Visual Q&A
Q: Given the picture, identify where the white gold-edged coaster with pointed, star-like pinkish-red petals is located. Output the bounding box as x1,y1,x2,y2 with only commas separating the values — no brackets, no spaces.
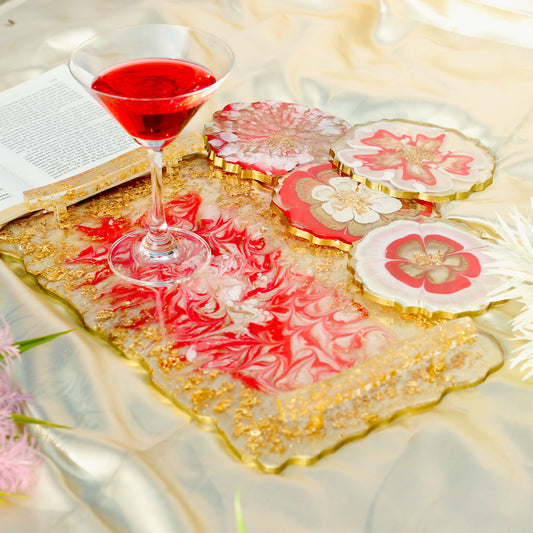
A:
331,120,495,202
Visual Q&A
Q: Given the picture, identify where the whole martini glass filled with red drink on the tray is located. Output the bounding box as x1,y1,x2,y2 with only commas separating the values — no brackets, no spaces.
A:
69,24,233,287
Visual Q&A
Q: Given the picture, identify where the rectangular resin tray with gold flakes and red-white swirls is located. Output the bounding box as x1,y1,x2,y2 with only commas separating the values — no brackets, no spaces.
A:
0,152,503,472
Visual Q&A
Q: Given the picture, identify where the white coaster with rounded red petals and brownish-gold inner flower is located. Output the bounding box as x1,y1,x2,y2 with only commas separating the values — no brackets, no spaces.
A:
349,220,502,318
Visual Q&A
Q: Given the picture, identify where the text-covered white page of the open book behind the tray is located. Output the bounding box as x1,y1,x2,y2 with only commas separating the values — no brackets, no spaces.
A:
0,65,139,188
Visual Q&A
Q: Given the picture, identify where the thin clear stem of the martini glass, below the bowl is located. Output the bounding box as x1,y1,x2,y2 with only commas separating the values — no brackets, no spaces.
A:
142,148,175,255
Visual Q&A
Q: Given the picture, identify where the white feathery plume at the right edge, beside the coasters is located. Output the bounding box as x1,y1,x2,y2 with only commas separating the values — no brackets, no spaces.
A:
488,198,533,380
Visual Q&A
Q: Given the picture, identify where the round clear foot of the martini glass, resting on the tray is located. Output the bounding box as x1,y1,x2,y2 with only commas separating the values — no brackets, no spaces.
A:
108,227,211,287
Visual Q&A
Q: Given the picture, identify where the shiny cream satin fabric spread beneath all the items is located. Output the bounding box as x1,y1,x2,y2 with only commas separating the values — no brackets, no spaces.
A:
0,0,533,533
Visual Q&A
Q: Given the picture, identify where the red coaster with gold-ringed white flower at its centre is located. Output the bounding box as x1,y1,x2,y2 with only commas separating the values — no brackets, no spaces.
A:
272,162,438,251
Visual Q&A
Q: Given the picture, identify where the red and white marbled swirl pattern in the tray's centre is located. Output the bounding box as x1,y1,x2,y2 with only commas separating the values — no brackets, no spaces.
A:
71,195,394,394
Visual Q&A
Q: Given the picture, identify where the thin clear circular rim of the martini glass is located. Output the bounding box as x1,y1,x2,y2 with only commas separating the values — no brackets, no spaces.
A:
68,23,235,102
